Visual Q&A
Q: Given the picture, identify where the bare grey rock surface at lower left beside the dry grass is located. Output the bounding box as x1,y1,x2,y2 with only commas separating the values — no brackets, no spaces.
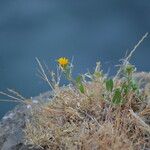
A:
0,92,52,150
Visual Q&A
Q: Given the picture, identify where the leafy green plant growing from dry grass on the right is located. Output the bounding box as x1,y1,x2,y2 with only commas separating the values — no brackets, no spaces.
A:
105,64,140,104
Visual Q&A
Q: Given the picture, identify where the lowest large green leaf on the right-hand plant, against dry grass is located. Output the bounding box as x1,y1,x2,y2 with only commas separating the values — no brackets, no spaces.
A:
112,89,122,104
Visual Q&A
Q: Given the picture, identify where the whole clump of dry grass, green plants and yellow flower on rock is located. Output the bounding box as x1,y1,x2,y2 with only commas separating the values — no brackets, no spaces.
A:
1,35,150,150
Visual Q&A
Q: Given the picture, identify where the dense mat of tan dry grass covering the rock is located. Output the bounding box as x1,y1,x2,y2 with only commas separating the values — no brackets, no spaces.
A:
25,81,150,150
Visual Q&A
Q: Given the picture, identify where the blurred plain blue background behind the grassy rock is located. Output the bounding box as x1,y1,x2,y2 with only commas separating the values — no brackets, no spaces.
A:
0,0,150,118
